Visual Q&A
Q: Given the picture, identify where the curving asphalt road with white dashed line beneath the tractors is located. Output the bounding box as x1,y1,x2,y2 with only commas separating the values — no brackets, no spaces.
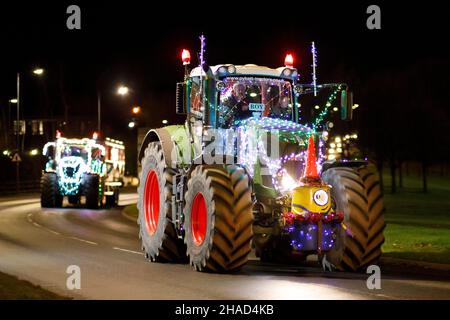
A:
0,190,450,300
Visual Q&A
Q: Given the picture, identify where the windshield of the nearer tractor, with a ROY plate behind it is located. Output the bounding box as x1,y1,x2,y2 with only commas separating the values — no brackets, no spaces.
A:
218,77,293,127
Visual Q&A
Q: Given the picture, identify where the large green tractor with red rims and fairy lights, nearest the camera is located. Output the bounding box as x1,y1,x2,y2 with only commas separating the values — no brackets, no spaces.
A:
138,42,385,272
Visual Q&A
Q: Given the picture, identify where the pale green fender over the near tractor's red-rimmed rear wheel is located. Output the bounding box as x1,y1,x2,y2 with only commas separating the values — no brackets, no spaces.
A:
138,125,190,168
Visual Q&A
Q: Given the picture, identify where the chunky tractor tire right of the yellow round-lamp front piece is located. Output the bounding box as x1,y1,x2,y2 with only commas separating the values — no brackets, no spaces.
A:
322,165,385,271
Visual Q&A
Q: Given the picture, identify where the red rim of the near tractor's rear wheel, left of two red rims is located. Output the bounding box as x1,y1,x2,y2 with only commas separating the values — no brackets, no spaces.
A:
144,170,160,234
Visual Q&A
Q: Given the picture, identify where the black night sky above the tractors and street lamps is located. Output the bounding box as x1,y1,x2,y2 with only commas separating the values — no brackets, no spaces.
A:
0,1,449,172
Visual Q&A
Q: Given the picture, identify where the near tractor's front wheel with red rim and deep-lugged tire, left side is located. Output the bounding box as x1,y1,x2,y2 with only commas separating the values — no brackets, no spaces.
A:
184,165,253,273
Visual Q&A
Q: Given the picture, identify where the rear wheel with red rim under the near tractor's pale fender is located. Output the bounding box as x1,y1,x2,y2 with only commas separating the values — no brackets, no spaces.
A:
137,142,186,262
